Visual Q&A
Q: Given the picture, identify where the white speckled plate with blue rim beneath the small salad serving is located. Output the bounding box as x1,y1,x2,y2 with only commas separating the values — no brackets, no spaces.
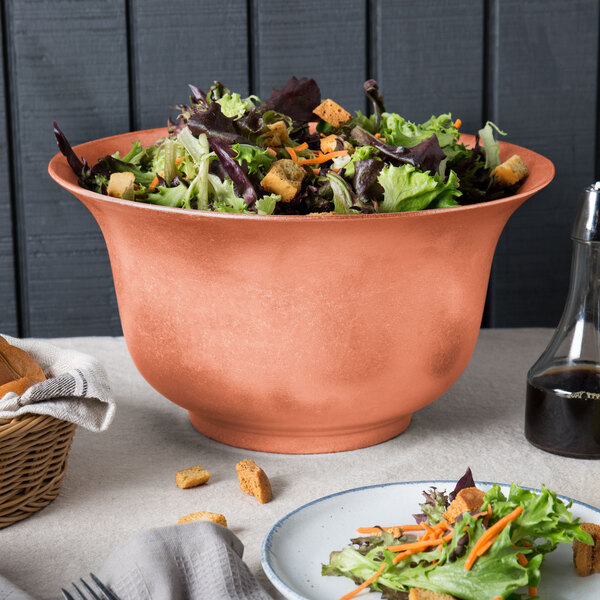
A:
261,481,600,600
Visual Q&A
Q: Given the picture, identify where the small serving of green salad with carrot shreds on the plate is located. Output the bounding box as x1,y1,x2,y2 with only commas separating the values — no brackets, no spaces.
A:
322,469,593,600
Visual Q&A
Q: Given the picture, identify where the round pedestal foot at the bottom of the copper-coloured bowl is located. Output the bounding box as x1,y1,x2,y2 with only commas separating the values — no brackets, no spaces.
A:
189,411,412,454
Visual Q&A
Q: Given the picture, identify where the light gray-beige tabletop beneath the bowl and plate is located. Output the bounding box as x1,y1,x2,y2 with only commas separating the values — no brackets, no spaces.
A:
0,329,600,598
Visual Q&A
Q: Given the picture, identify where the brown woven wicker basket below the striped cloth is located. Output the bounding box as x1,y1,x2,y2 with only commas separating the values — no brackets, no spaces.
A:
0,415,77,529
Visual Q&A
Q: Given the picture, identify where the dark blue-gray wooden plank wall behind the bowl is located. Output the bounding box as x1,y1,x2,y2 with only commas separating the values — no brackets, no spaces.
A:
0,0,599,336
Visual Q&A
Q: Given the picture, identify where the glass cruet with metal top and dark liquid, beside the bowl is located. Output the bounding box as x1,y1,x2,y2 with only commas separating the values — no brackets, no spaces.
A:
525,182,600,458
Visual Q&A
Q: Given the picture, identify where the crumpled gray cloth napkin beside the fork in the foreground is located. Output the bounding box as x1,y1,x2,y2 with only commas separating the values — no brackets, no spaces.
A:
0,522,272,600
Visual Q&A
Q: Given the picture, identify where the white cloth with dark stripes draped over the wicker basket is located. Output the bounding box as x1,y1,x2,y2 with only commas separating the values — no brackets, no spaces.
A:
0,335,115,432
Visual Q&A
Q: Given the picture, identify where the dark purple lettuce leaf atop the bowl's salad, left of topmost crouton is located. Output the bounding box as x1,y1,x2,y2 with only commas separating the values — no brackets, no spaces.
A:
258,77,321,122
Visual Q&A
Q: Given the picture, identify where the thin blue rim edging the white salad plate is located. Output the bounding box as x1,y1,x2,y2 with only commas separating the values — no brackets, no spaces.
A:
260,479,600,600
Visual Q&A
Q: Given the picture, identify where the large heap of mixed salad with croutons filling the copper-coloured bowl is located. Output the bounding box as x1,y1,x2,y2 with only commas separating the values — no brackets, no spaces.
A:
54,77,527,215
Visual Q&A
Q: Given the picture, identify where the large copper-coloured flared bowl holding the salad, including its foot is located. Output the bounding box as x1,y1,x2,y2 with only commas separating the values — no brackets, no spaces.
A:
49,129,554,453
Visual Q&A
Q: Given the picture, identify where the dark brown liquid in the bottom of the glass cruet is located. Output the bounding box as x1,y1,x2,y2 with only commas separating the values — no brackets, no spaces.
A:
525,366,600,458
